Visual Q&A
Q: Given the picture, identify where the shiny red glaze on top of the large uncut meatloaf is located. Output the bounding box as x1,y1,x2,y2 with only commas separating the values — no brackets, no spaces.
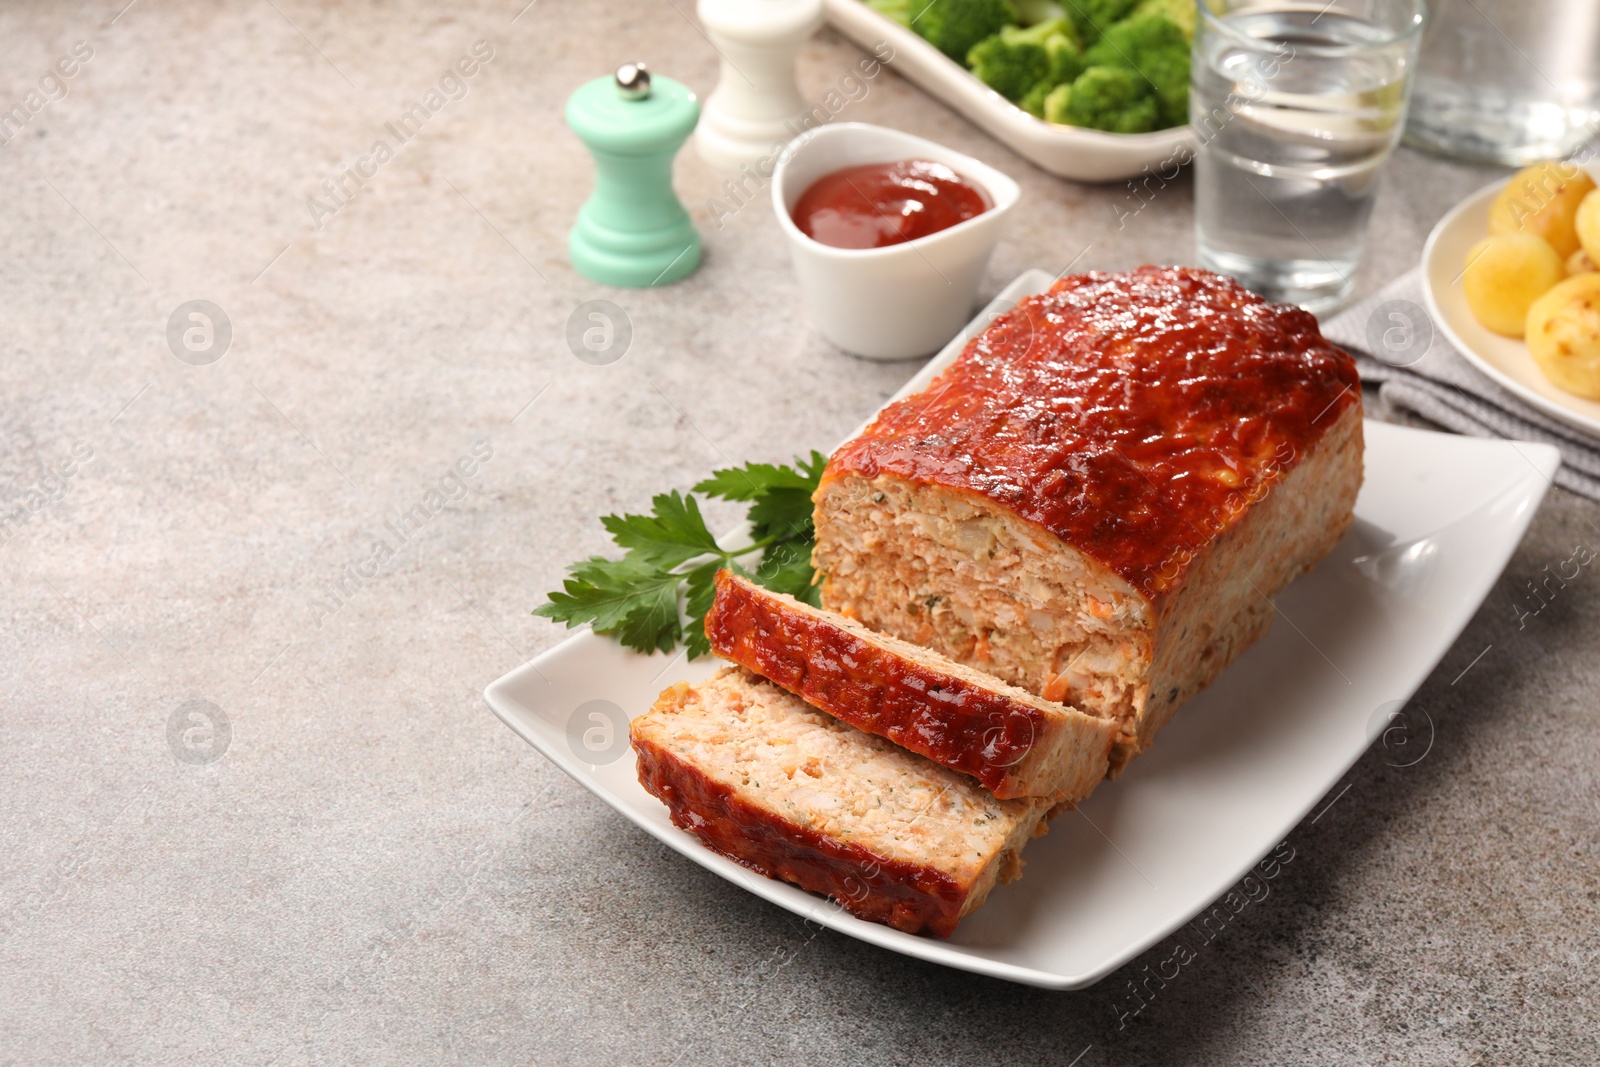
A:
824,267,1360,600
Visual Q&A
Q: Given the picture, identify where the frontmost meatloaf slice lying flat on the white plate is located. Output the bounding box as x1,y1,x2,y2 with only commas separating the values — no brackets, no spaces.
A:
632,667,1050,936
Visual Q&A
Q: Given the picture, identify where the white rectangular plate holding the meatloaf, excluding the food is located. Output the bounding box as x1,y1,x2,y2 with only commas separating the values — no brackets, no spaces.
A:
485,270,1558,989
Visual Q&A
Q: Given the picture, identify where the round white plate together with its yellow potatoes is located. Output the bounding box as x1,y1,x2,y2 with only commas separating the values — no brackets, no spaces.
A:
1422,165,1600,437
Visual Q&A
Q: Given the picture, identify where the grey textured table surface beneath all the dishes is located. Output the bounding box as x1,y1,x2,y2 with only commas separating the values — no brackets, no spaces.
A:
0,0,1600,1067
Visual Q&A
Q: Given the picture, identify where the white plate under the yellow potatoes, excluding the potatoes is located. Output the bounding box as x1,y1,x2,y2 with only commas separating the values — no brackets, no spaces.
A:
1422,179,1600,437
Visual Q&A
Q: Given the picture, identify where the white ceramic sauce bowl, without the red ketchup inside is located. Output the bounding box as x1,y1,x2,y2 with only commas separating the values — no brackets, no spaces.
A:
773,122,1021,360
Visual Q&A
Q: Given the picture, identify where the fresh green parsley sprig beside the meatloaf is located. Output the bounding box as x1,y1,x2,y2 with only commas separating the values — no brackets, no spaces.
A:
533,451,827,659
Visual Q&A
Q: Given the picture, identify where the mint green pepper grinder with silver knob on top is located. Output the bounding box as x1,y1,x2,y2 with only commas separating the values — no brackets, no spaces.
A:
566,62,701,288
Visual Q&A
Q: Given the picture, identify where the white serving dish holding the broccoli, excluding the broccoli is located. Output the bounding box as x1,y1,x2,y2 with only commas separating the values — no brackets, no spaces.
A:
824,0,1195,181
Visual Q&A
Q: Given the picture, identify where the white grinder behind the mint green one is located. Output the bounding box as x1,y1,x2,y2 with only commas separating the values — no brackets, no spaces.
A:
694,0,822,170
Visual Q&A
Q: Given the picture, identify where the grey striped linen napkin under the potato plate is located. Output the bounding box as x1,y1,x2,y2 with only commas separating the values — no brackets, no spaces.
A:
1322,270,1600,501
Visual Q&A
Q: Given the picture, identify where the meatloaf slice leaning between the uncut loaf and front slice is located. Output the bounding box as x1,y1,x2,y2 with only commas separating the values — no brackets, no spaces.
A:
706,571,1117,803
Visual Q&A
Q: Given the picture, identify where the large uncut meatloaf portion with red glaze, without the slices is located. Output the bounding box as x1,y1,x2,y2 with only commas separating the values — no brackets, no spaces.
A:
813,267,1362,771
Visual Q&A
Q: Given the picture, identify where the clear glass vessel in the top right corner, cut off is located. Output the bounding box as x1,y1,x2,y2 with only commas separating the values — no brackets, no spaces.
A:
1405,0,1600,166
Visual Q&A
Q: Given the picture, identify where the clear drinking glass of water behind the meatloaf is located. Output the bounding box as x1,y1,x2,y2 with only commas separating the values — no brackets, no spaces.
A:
1189,0,1426,314
